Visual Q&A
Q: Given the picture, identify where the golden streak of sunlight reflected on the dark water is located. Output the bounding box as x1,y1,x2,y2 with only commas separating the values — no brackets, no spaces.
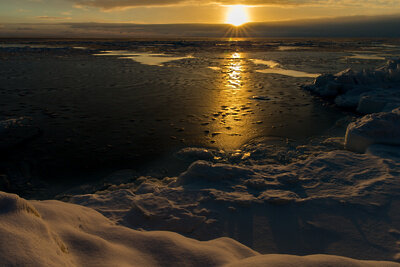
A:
205,52,254,150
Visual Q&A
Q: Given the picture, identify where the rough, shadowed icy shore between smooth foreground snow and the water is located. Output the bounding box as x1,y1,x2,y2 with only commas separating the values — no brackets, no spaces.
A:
67,147,400,260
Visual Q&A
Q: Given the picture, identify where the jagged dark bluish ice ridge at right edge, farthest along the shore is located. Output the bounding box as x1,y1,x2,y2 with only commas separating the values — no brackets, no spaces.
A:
304,59,400,113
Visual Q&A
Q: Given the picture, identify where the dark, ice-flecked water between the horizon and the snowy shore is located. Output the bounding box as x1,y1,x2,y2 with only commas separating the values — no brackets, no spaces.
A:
0,40,398,197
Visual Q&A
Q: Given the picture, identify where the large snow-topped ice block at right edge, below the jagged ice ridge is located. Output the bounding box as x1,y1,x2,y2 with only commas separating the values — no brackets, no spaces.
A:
345,108,400,153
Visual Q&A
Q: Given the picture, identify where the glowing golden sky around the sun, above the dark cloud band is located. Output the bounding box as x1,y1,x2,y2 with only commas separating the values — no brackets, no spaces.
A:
0,0,400,37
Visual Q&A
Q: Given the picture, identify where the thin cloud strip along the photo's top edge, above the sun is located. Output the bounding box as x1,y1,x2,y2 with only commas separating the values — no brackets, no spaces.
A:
69,0,398,10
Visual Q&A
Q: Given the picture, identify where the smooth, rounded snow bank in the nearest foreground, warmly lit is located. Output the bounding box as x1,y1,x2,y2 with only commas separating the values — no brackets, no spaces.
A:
0,192,400,267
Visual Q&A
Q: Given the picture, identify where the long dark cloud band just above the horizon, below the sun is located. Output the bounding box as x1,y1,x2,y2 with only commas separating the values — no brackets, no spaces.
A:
0,15,400,38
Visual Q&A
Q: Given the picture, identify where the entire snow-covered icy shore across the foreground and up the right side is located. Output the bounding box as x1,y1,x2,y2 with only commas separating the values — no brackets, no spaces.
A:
0,52,400,266
